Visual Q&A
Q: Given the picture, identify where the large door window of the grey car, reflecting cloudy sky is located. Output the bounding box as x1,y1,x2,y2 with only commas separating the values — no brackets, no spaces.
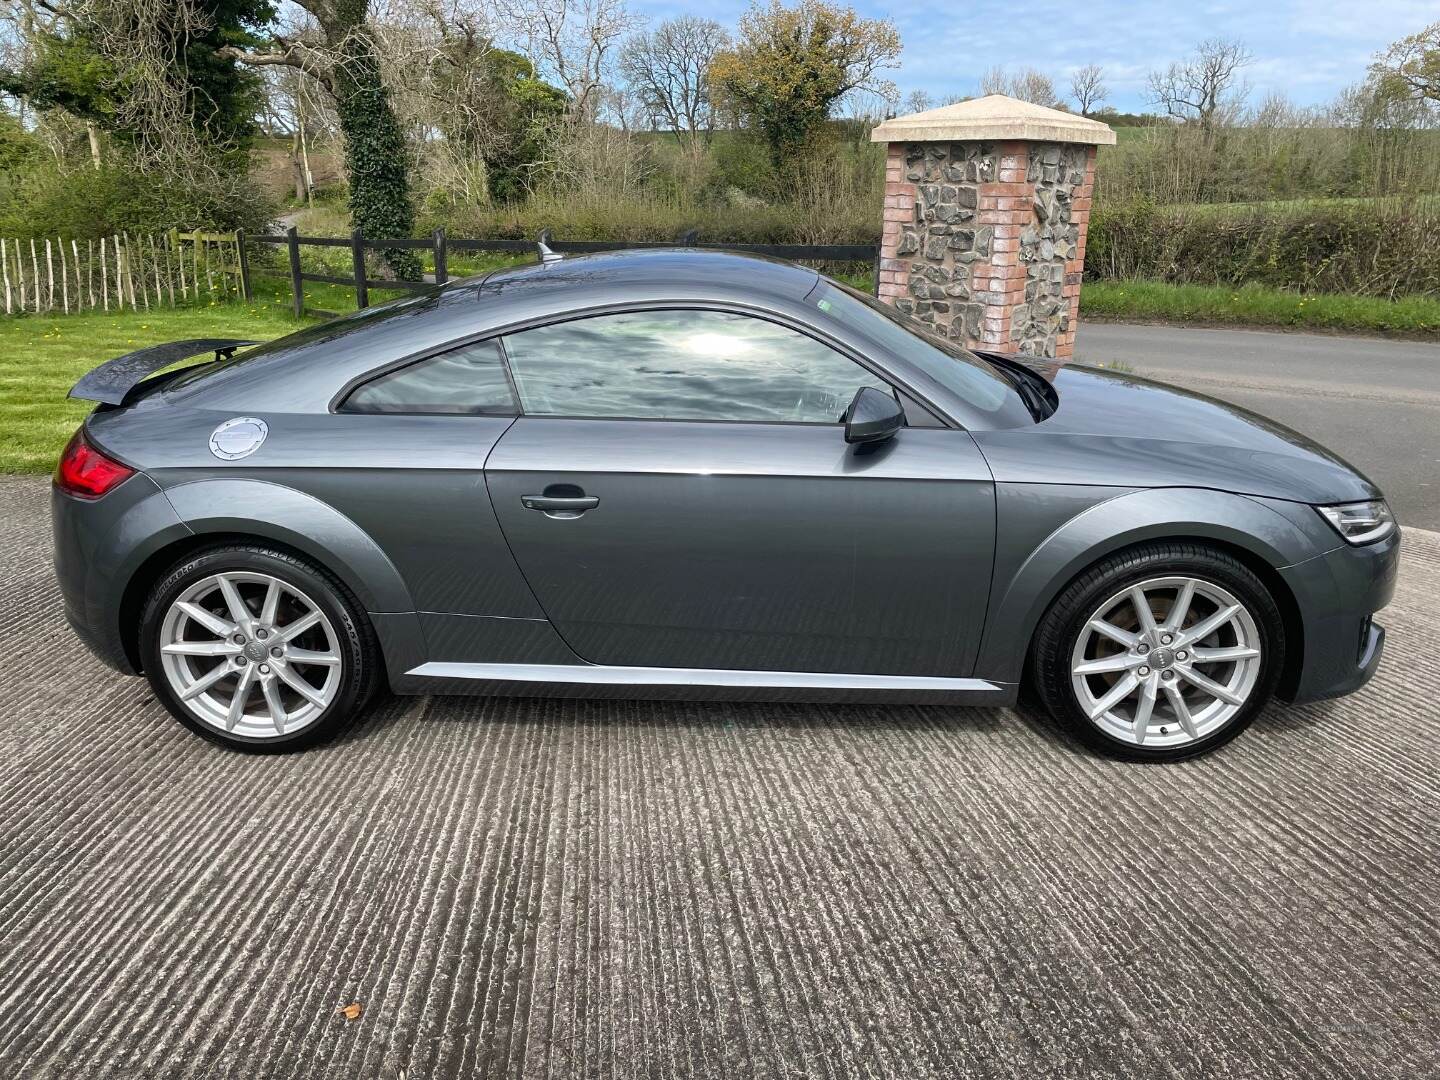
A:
505,310,891,423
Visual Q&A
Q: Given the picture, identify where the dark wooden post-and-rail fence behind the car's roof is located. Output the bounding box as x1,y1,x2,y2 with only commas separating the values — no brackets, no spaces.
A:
240,228,880,317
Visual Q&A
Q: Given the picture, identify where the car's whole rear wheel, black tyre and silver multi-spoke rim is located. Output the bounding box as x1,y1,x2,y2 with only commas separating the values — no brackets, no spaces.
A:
140,544,382,753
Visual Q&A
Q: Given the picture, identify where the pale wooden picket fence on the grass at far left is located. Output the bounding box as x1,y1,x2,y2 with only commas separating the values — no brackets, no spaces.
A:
0,229,251,315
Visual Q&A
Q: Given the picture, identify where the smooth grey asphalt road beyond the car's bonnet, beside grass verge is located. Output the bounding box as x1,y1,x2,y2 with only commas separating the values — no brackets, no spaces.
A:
1076,328,1440,530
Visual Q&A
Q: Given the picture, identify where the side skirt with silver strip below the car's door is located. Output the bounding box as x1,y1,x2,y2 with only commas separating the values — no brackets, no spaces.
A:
393,662,1015,707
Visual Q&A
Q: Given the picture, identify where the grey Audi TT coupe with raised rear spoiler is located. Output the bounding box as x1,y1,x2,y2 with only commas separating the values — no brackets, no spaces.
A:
53,249,1400,760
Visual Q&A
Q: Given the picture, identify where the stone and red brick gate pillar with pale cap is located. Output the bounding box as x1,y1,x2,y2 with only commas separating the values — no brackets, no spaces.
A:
870,94,1115,359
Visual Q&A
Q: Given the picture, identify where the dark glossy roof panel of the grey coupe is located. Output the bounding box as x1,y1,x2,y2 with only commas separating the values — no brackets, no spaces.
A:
481,248,819,300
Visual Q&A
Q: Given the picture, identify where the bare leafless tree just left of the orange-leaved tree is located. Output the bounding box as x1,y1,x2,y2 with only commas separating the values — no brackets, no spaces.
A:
619,14,730,154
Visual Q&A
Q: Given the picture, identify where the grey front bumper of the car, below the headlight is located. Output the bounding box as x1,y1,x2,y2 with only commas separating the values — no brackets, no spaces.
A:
1280,528,1400,701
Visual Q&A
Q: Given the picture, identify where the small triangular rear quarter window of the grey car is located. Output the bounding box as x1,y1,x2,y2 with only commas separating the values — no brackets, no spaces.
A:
340,341,516,416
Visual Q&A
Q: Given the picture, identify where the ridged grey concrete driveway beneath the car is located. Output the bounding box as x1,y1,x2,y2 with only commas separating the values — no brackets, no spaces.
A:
0,480,1440,1080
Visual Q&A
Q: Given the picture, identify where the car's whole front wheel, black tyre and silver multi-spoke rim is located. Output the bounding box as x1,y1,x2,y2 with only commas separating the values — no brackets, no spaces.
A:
1030,541,1286,762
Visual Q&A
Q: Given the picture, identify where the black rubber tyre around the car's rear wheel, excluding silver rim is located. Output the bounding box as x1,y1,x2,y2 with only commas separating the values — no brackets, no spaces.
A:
140,546,373,753
